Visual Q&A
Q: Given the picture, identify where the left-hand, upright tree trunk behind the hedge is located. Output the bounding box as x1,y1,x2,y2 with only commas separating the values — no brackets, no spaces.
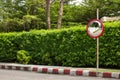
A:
46,0,51,29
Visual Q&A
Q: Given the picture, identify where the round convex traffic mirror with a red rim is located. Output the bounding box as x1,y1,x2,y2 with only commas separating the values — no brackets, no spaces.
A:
87,20,103,38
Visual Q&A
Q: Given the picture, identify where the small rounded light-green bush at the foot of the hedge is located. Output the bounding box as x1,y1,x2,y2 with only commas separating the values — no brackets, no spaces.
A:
17,50,31,64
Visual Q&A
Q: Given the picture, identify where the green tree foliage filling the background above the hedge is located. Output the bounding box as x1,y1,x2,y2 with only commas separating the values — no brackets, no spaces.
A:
0,0,120,32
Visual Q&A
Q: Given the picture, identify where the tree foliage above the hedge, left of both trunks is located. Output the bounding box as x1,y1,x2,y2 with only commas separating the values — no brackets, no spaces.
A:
0,0,45,32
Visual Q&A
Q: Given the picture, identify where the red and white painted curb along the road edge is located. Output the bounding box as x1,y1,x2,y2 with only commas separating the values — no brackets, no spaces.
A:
0,64,120,79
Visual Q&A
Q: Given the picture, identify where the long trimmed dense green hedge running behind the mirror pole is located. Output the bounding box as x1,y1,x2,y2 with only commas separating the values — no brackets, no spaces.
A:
0,22,120,68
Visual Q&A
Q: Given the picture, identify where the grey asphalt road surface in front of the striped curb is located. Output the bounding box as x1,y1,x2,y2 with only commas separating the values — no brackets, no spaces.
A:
0,69,118,80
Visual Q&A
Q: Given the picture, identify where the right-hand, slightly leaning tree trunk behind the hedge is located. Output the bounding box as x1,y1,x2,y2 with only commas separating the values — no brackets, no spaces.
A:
57,0,64,29
